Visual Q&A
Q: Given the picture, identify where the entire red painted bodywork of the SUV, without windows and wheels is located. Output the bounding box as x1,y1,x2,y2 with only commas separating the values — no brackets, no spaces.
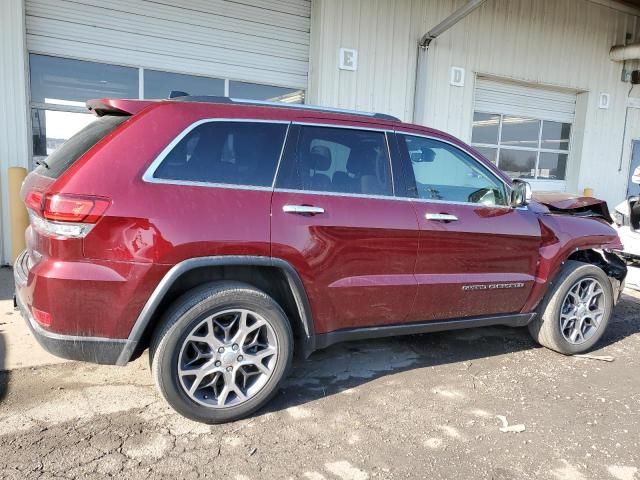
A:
13,100,617,339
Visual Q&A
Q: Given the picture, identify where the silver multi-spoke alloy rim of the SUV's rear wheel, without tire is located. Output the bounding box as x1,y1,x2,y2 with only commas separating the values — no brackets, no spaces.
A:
178,309,278,408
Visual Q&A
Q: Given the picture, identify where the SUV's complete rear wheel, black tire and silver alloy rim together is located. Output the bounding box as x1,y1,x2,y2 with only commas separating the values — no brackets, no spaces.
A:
151,282,293,423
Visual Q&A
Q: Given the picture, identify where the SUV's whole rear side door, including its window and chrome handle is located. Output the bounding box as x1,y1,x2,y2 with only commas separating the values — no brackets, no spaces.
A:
271,124,419,333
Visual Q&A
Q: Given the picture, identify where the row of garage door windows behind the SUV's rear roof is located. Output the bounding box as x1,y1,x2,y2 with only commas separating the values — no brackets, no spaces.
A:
29,54,304,166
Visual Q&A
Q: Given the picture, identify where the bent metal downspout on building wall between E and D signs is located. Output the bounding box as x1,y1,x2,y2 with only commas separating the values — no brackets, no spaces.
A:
413,0,486,123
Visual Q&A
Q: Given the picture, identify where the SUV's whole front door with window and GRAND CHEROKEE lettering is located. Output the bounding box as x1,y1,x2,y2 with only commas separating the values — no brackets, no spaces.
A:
397,130,540,320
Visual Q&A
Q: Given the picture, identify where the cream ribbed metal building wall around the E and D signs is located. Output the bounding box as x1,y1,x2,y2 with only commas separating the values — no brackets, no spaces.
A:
309,0,640,207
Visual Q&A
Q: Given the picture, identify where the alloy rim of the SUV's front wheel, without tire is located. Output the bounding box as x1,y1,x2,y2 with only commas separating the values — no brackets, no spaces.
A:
560,277,605,345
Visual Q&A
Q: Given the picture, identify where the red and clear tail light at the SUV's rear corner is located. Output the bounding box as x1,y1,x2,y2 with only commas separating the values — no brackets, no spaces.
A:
25,191,111,238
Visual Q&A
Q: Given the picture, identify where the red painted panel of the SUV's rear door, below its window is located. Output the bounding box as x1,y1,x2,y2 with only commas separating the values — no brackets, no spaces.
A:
271,192,419,333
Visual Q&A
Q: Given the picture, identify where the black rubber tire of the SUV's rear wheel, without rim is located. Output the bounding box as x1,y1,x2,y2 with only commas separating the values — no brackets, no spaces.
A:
149,282,293,424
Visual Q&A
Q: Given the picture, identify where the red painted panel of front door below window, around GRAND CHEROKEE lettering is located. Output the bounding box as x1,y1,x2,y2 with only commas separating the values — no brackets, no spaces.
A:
412,201,540,321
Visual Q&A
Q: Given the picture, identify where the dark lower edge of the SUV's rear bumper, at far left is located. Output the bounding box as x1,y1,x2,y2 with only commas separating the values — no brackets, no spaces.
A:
13,251,126,365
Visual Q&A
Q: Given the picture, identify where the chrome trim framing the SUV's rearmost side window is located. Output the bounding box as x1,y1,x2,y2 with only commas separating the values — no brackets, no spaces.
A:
142,118,291,191
